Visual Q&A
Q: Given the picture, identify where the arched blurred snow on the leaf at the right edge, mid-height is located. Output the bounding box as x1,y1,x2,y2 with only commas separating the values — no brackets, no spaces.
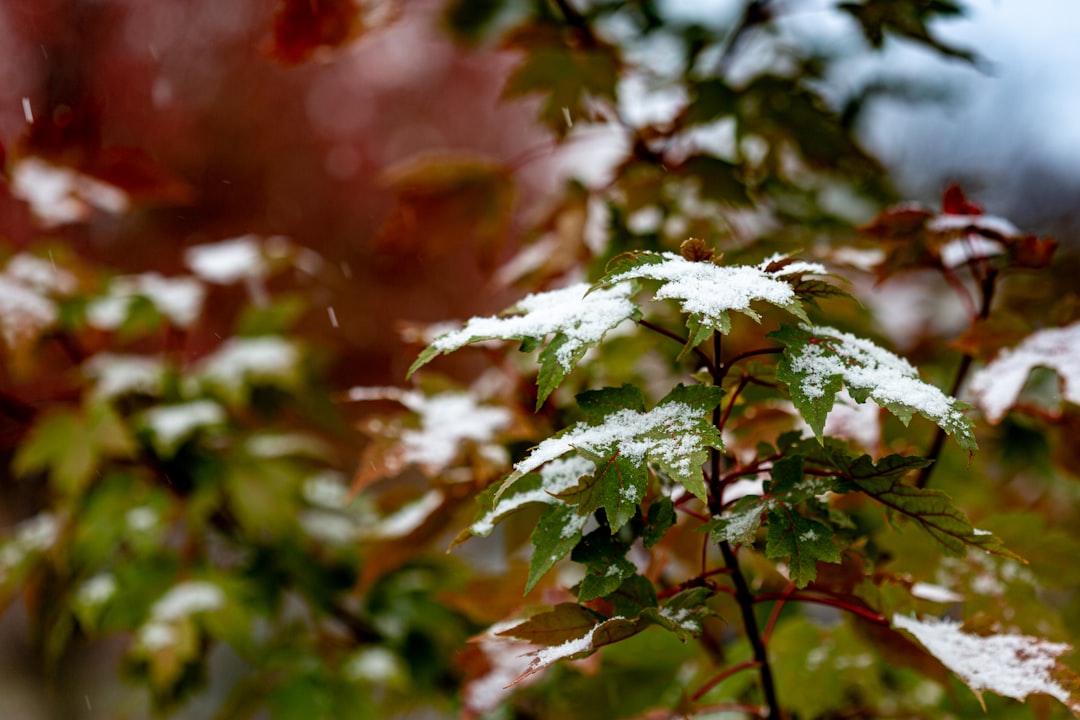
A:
969,323,1080,423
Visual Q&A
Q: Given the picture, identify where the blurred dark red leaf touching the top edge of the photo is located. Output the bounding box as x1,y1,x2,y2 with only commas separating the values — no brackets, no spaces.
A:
267,0,360,65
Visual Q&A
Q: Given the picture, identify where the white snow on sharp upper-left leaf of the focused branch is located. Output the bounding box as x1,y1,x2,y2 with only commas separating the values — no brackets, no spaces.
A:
431,283,635,371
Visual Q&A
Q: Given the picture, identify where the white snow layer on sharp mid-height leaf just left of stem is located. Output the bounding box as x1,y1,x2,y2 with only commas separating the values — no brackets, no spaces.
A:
504,403,701,487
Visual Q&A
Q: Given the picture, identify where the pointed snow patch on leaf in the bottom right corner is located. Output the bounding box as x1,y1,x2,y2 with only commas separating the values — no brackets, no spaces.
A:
892,615,1080,712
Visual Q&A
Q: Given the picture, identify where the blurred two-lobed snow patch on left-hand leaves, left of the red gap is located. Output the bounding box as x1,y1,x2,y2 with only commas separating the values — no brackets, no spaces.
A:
86,272,206,330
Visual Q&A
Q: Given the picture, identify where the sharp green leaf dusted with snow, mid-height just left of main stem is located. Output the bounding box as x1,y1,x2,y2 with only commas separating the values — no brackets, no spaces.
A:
496,385,724,509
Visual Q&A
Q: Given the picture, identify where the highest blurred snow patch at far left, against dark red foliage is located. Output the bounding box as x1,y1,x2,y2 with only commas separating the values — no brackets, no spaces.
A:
11,158,131,228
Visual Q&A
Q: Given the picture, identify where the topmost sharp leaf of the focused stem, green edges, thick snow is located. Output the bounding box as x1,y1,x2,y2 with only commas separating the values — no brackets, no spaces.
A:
595,252,826,354
